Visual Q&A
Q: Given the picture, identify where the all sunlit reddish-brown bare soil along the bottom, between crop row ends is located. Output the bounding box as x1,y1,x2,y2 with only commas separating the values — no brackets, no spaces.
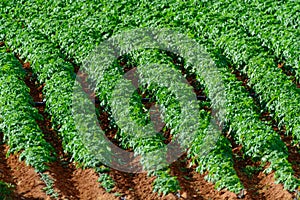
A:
0,145,293,200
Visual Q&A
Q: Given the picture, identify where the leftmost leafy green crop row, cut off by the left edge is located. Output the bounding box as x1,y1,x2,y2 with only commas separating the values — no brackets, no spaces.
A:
0,47,57,197
